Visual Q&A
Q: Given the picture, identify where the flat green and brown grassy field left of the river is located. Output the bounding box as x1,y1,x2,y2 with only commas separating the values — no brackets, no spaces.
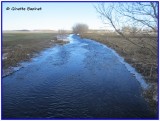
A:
2,32,64,69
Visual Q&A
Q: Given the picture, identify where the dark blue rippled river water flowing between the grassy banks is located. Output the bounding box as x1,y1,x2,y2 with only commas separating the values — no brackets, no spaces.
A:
2,35,156,119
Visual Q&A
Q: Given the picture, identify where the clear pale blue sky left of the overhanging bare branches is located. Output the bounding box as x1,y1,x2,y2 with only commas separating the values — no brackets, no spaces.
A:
2,2,104,30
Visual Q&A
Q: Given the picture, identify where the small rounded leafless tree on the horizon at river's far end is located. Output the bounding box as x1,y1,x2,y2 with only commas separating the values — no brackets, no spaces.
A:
72,23,88,34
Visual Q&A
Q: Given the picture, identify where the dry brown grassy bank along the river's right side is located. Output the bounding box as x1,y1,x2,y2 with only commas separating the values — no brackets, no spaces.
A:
81,33,158,112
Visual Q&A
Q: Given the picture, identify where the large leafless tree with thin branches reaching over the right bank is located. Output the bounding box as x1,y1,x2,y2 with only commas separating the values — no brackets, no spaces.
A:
95,2,158,55
